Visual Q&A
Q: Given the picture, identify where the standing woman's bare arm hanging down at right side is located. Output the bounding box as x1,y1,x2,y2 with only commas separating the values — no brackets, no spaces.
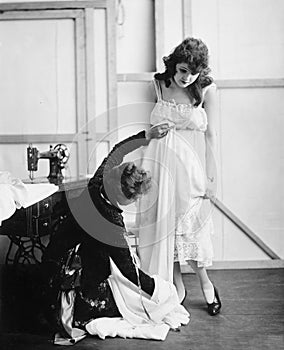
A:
204,84,218,197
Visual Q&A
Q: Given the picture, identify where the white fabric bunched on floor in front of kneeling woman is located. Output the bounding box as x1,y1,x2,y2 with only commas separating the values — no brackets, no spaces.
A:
86,259,190,340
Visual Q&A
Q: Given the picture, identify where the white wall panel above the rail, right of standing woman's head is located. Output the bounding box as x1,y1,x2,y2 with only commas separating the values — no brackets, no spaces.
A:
191,0,284,79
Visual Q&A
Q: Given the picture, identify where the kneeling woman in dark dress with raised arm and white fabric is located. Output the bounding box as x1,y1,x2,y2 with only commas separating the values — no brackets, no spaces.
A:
42,124,189,344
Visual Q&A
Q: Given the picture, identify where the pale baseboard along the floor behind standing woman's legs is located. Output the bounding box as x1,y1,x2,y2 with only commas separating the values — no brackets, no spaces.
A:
181,259,284,273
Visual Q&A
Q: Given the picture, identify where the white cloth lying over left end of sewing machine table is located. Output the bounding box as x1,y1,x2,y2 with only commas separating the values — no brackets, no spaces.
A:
0,171,58,225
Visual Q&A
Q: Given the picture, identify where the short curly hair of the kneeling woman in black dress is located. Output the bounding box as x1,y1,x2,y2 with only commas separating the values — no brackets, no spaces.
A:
120,163,151,200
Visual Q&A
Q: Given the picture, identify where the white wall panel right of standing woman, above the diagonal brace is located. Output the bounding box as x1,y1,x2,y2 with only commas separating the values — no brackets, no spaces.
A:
221,88,284,257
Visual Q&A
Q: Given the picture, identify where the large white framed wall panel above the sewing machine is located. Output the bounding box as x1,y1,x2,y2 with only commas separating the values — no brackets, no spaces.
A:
0,19,76,134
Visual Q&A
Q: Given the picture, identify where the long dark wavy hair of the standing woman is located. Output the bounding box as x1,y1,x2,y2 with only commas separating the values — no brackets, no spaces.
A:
154,38,213,106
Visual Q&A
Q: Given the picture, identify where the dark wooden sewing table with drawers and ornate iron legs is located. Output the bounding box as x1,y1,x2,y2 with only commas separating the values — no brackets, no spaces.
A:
0,178,88,264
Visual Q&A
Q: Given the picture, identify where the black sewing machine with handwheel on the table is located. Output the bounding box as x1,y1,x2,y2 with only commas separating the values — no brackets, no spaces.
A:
27,144,70,181
